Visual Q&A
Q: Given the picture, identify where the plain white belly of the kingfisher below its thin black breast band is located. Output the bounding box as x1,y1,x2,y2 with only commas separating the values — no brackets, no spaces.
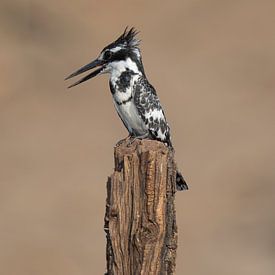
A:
114,100,148,136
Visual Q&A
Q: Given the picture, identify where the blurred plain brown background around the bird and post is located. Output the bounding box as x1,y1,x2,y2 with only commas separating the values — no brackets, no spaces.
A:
0,0,275,275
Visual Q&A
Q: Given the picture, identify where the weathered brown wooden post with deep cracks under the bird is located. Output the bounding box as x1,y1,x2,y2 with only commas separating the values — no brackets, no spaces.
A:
105,140,177,275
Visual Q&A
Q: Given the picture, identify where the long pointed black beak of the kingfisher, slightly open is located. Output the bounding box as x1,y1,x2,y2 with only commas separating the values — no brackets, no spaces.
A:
65,59,104,88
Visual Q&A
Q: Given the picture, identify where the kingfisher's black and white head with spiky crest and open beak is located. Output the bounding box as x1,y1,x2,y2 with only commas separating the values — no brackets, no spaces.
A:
65,28,144,88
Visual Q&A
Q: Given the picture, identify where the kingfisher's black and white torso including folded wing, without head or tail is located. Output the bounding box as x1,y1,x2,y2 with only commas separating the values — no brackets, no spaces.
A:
110,70,171,145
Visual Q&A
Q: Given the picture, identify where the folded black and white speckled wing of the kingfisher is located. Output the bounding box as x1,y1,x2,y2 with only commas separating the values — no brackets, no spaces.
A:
134,77,171,146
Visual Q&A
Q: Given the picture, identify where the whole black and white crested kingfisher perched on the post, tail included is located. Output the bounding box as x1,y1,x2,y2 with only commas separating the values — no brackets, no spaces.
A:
65,27,188,191
